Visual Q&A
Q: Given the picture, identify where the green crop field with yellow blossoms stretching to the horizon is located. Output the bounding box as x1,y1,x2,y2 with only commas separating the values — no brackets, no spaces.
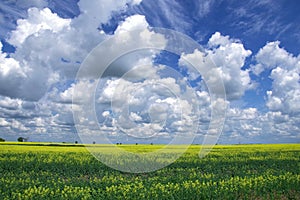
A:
0,142,300,200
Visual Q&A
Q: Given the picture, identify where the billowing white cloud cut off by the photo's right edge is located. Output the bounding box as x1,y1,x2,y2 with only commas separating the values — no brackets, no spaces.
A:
252,41,300,115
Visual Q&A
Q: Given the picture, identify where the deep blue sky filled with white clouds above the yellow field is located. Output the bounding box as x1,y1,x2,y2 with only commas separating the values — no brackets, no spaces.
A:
0,0,300,144
